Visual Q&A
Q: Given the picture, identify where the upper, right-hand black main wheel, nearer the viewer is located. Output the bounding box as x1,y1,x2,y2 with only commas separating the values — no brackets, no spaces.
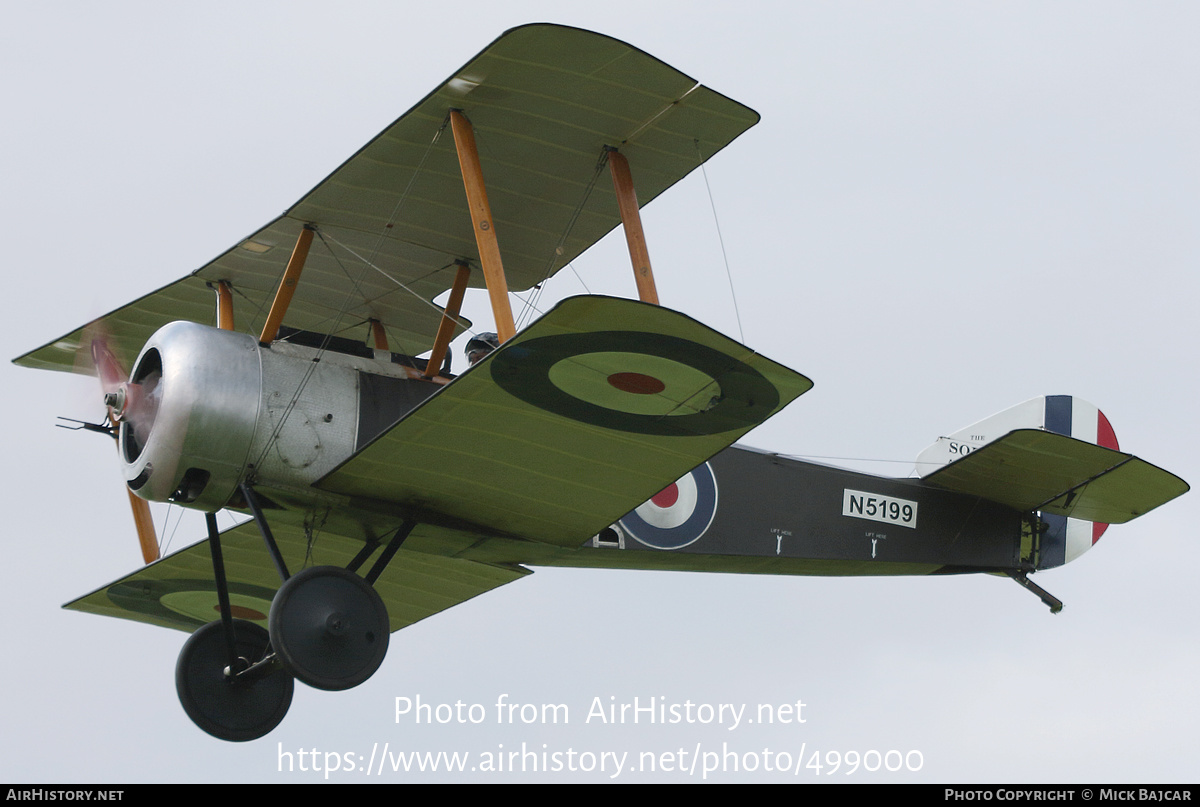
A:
268,566,391,689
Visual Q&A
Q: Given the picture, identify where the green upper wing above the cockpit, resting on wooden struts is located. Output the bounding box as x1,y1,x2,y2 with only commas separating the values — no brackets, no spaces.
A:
17,24,758,372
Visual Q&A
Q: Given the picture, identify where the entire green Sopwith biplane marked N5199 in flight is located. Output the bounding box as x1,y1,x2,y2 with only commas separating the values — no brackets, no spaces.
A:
16,24,1188,741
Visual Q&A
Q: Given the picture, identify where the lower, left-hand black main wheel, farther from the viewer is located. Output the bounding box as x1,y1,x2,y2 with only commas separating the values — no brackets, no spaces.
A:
175,620,295,742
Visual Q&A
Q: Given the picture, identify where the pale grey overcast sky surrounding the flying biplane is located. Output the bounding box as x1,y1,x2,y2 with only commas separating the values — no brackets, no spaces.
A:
0,1,1200,783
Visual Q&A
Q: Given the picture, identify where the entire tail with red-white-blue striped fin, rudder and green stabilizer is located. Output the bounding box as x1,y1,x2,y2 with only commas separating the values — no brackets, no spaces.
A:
917,395,1188,568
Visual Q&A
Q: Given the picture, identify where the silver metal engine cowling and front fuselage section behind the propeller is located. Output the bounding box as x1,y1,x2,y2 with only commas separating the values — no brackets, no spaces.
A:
114,322,438,510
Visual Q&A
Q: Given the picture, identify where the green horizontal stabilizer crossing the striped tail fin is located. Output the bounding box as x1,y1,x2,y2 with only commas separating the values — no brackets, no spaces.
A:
923,429,1188,524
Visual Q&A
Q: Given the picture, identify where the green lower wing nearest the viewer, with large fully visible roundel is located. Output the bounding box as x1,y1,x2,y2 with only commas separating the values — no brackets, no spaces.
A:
317,297,812,546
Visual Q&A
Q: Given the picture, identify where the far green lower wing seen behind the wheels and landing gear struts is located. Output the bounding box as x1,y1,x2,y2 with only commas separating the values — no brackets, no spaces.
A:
64,521,530,633
